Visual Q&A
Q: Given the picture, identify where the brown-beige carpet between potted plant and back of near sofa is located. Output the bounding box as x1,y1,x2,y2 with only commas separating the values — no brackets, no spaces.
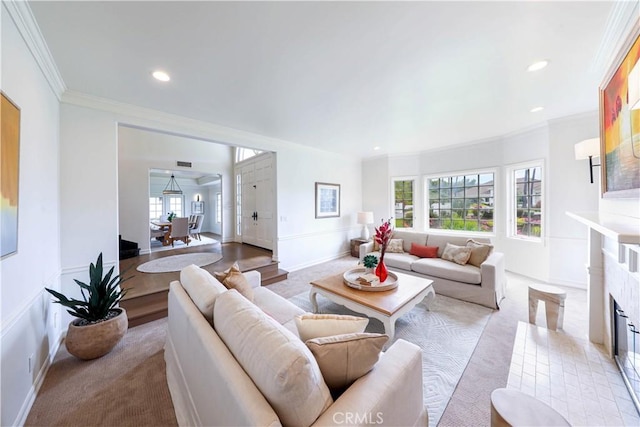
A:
25,319,177,427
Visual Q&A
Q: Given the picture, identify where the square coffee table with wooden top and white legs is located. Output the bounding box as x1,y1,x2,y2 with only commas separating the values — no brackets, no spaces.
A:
309,271,436,343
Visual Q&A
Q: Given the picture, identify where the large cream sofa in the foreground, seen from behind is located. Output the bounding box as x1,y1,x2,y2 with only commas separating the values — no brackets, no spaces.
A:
165,266,428,426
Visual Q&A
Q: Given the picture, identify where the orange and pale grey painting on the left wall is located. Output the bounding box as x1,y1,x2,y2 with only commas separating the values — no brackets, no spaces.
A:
0,93,20,258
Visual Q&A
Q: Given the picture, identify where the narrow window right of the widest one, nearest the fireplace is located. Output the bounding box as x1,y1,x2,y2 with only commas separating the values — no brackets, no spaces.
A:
510,163,543,239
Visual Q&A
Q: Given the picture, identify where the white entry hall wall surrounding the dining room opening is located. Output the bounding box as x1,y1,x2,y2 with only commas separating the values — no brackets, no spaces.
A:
118,126,234,253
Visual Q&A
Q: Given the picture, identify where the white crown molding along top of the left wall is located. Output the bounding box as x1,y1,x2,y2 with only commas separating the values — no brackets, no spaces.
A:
2,0,67,100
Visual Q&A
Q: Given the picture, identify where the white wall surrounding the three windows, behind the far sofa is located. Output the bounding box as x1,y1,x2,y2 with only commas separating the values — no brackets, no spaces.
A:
362,112,598,287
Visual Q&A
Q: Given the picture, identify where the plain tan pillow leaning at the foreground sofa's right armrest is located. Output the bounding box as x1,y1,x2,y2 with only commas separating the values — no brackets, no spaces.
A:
306,333,389,391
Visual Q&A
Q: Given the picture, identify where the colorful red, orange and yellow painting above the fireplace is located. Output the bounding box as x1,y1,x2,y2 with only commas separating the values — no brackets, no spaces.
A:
600,24,640,198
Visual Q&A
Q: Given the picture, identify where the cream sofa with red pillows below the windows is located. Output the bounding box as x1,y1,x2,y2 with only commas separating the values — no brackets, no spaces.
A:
360,230,506,309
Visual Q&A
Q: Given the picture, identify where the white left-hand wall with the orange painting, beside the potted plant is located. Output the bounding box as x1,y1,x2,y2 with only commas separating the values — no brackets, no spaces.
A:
0,2,60,426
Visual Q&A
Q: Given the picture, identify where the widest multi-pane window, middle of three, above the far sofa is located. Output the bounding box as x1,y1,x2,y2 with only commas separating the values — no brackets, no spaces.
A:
426,172,495,233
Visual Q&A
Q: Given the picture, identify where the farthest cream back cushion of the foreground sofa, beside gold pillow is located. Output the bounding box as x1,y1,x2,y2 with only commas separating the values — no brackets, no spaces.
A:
180,264,227,323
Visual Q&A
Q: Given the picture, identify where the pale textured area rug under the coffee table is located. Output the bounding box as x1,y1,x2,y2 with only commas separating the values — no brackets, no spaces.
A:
289,292,493,426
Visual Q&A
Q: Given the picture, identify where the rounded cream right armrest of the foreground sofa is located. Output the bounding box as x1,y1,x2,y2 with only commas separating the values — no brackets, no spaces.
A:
314,339,428,426
